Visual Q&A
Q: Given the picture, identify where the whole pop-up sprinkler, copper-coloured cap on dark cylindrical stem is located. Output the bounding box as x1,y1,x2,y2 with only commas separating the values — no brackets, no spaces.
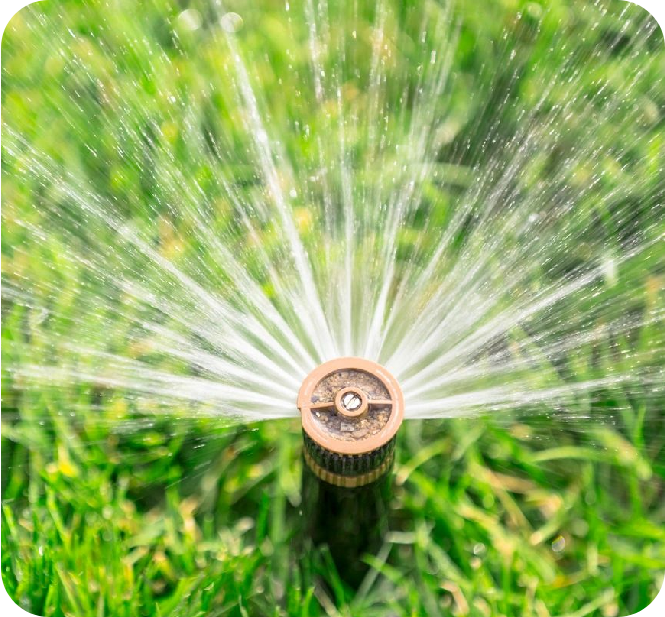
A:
298,358,404,586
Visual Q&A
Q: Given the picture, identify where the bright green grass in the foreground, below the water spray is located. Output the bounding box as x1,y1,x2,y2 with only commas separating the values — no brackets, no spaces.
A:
0,398,665,617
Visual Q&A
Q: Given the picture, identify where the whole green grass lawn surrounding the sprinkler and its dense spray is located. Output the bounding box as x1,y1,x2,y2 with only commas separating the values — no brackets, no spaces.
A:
0,0,665,617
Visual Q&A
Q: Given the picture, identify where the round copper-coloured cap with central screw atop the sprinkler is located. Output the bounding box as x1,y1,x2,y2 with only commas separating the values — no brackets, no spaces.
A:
298,358,404,454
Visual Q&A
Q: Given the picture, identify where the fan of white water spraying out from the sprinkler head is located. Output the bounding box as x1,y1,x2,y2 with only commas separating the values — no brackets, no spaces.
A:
0,0,665,434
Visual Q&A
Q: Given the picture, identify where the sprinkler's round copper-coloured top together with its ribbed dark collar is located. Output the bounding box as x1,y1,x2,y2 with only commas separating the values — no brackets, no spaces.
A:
298,357,404,486
